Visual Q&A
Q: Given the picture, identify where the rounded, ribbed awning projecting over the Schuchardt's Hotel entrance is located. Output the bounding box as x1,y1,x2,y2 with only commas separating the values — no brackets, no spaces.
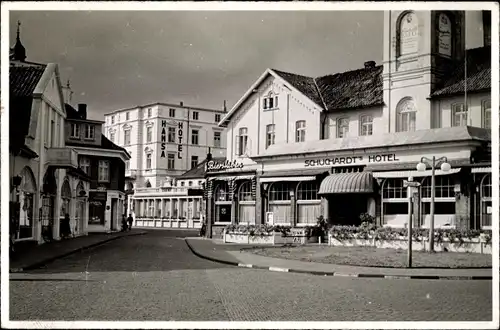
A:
318,172,373,195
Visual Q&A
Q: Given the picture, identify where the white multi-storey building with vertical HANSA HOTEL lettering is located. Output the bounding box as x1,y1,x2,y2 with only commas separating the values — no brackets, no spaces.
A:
103,102,226,190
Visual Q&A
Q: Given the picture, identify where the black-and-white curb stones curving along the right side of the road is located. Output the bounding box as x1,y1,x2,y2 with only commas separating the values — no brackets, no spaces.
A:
184,239,493,281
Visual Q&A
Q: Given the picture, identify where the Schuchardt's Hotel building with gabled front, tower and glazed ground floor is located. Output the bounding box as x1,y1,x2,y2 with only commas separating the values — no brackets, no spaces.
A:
206,11,492,235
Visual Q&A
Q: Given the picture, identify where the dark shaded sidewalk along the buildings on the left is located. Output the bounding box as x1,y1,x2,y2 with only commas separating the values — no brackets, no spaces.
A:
10,230,146,273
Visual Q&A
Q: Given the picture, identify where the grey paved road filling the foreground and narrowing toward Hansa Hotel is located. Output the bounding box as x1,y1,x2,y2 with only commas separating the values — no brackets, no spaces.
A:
10,230,492,321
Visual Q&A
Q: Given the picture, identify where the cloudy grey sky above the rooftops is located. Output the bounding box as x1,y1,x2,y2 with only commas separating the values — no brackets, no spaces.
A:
10,11,484,120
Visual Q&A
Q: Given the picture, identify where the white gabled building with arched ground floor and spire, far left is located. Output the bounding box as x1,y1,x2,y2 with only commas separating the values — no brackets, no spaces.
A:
9,22,89,250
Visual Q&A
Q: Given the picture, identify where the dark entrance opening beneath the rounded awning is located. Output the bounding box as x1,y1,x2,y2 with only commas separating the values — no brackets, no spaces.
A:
329,194,368,226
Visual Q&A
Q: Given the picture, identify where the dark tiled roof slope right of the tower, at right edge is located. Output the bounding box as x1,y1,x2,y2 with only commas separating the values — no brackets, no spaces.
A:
431,46,491,97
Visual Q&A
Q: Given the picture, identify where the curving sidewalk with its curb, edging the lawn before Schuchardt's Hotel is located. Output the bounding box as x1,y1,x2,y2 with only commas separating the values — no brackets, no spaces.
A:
186,238,492,280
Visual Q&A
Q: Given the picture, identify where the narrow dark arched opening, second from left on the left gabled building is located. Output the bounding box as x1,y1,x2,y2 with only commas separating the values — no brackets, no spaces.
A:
40,168,57,241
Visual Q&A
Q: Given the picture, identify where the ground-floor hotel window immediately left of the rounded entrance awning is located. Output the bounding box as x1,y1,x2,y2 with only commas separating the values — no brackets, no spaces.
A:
297,181,321,225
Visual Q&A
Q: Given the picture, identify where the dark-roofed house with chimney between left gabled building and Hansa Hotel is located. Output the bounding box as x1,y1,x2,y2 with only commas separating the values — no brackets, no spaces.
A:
64,104,130,232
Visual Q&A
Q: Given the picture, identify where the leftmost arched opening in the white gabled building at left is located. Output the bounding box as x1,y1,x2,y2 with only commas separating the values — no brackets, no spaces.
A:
16,166,36,239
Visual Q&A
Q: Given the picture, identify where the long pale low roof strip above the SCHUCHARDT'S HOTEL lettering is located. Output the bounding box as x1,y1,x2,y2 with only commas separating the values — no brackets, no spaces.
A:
251,126,491,160
